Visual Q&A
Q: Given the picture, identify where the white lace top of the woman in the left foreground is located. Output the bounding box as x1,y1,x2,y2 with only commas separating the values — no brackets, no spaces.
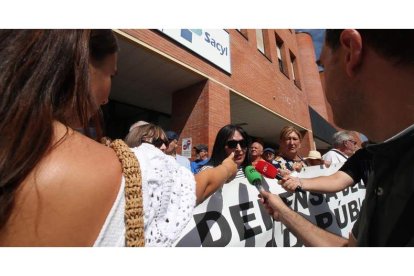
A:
94,143,196,246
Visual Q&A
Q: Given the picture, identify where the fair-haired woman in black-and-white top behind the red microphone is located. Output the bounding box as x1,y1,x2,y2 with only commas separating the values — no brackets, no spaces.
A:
275,126,306,175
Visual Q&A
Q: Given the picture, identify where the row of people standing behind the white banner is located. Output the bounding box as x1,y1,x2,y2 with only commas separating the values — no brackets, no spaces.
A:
122,121,352,182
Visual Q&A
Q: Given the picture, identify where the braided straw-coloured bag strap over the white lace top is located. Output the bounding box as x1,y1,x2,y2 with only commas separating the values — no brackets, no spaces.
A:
110,139,145,247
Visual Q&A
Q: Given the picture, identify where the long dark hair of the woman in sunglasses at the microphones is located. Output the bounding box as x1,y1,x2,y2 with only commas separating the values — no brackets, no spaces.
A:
207,125,250,167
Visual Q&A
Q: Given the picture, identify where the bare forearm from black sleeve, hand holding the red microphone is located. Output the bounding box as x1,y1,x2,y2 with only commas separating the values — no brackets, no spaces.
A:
281,171,354,193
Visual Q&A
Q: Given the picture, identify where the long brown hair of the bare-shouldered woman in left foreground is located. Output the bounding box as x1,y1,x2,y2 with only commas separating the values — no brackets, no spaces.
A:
0,30,118,228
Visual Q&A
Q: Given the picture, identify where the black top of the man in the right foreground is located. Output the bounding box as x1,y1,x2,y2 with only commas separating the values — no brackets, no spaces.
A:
352,125,414,246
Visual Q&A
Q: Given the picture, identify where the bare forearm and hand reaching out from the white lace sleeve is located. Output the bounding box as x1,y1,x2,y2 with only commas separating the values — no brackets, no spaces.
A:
194,153,237,205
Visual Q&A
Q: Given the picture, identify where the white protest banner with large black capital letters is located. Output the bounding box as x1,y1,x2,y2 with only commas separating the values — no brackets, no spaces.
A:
175,164,365,247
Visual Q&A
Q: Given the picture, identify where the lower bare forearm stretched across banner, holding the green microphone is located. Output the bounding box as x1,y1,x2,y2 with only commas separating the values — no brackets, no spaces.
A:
260,191,348,246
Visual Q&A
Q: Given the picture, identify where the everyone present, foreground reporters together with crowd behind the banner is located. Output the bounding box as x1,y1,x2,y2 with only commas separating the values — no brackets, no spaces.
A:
0,30,414,246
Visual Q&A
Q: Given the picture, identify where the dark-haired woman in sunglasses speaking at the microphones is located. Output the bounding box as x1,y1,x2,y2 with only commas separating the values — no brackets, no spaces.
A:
201,125,250,178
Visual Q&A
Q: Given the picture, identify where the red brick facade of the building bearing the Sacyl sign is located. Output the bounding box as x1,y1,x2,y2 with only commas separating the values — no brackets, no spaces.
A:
116,29,331,158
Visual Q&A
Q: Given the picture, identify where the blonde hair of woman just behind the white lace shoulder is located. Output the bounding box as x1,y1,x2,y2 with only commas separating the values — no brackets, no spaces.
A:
124,124,167,148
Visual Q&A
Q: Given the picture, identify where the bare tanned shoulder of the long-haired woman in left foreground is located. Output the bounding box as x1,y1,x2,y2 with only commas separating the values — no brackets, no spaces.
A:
17,132,122,246
